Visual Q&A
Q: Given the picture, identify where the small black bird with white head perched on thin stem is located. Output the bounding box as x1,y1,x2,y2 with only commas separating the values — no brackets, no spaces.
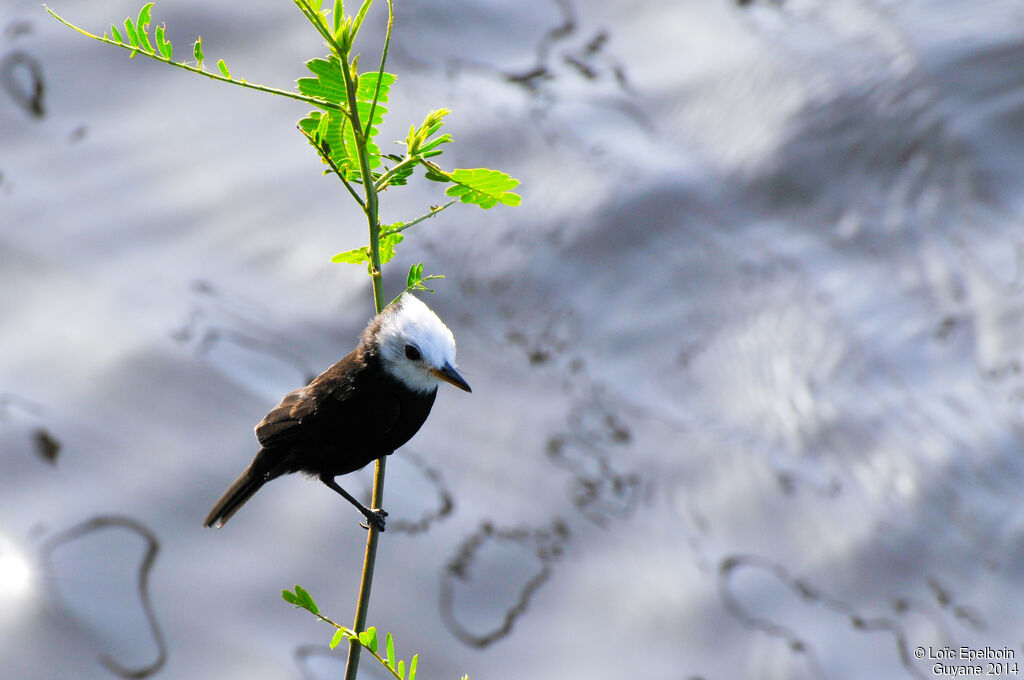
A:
203,292,472,532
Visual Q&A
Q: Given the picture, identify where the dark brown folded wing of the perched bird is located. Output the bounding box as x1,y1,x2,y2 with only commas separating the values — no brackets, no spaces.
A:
256,351,401,449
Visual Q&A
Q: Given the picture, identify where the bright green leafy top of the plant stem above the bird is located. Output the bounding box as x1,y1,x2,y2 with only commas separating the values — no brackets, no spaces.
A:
46,0,520,290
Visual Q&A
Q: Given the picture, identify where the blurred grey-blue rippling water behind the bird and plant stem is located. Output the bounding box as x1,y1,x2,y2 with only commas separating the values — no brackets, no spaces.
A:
0,0,1024,680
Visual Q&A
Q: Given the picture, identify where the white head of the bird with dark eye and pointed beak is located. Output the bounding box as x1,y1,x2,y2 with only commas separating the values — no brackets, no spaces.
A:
372,293,471,392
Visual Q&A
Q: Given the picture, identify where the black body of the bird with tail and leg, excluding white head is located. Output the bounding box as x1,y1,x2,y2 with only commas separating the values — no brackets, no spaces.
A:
204,294,469,529
